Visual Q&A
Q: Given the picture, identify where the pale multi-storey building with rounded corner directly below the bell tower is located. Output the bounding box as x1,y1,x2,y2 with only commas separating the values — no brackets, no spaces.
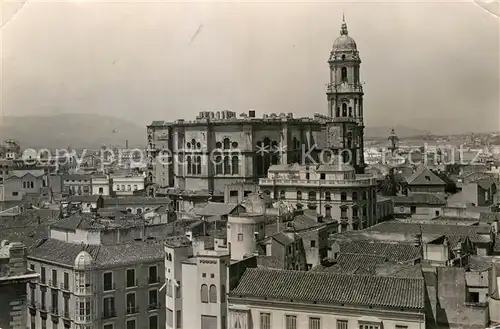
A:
259,164,377,231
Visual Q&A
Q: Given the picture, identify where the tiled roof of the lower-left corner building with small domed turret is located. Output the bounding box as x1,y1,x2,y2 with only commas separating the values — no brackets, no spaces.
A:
28,239,164,267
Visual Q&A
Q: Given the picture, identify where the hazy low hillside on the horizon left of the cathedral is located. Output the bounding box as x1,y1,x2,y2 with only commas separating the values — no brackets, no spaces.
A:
0,114,146,149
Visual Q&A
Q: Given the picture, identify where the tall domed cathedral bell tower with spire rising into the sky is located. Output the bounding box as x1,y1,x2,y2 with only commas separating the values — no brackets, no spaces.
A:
326,17,365,173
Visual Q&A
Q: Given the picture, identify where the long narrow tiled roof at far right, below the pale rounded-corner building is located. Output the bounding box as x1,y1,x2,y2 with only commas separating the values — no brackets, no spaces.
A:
366,221,491,243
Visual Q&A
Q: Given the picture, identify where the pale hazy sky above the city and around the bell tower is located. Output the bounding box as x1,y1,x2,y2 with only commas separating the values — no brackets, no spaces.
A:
1,0,500,132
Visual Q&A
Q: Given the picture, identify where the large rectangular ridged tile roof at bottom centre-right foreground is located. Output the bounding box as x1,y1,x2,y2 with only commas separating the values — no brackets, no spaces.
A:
230,268,425,309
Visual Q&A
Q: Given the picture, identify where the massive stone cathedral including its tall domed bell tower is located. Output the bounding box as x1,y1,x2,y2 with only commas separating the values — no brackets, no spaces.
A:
147,19,365,192
